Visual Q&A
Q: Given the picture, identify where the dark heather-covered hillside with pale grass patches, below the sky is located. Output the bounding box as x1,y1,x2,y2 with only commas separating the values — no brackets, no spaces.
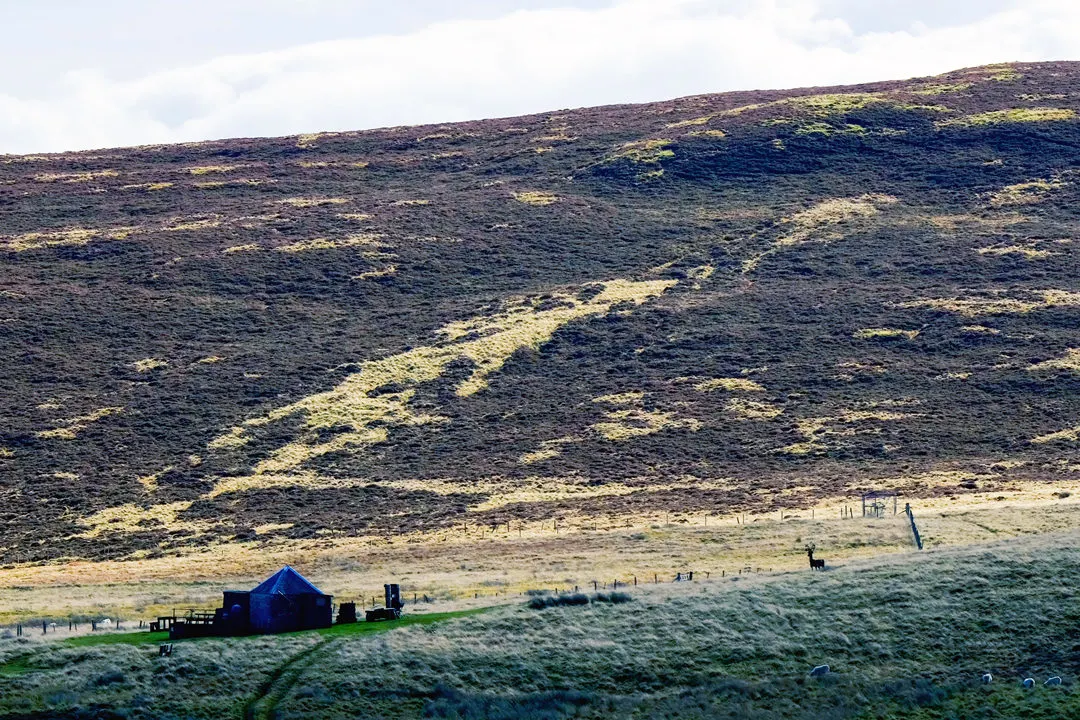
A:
0,63,1080,563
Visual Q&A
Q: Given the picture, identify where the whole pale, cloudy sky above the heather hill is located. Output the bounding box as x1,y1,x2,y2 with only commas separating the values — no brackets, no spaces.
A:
0,0,1080,153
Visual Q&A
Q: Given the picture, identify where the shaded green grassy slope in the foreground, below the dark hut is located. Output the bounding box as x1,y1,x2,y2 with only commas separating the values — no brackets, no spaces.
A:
0,532,1080,720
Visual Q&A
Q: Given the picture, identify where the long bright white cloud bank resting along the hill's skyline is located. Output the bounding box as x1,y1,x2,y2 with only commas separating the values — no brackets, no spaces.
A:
0,0,1080,152
